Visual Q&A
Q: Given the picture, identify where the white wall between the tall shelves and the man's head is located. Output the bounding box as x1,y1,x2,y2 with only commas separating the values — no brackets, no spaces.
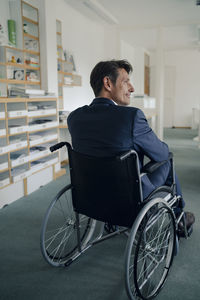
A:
56,0,104,111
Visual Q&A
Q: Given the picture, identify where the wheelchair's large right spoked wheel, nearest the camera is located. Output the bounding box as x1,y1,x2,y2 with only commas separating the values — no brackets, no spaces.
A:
125,198,176,300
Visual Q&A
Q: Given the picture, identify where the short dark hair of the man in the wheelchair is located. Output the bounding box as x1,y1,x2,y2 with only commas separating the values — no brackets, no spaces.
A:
90,59,133,97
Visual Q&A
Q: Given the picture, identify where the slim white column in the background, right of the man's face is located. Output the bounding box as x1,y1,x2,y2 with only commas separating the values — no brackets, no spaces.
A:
155,27,164,140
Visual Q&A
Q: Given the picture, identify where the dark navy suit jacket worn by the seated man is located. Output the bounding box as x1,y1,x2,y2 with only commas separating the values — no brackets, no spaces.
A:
68,98,169,198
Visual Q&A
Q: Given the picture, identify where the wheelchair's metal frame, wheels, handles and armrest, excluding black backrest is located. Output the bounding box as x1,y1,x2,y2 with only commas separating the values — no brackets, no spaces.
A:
40,142,188,300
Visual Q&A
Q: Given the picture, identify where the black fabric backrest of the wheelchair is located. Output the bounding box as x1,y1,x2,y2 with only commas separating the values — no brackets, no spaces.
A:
67,144,142,227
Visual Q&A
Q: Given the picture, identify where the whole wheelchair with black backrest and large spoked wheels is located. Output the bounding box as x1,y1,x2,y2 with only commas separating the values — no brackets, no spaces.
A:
40,142,189,300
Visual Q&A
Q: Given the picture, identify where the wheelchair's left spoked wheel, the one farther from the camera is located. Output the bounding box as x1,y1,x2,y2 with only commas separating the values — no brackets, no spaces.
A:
40,185,96,267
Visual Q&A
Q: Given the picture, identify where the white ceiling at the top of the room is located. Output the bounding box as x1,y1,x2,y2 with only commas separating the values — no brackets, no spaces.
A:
65,0,200,50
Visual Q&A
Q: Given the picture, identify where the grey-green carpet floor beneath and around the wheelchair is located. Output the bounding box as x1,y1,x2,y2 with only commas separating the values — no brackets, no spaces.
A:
0,129,200,300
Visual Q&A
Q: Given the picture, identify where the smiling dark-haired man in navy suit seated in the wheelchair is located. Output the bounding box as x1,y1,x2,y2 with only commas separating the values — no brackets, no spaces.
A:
68,60,194,230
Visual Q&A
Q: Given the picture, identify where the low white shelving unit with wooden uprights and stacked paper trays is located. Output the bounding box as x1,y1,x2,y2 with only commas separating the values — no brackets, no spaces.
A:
0,97,63,207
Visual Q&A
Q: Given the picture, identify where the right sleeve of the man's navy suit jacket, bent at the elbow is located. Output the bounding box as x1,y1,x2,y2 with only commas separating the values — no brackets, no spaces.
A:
133,109,169,162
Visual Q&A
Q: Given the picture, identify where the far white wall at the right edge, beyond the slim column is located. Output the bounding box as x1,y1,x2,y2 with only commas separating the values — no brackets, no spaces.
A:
165,50,200,127
